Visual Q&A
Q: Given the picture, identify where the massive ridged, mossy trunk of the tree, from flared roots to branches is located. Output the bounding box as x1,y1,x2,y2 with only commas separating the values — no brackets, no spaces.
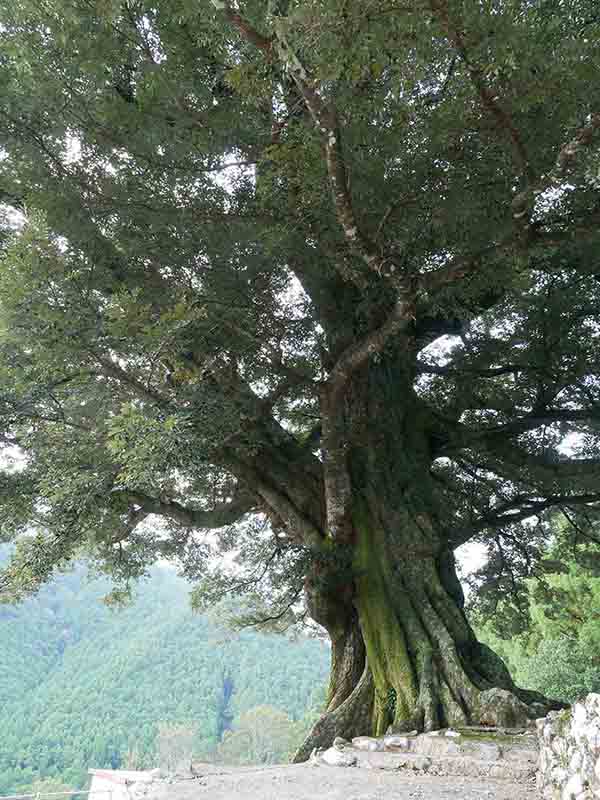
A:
296,360,556,760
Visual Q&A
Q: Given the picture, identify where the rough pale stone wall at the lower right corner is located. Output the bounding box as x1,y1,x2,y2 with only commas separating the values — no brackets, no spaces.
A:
537,694,600,800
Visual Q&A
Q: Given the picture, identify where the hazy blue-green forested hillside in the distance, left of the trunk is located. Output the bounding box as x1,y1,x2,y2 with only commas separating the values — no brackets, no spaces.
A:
0,553,329,794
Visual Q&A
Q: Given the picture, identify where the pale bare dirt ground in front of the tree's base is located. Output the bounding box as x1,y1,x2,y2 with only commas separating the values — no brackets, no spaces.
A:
151,764,537,800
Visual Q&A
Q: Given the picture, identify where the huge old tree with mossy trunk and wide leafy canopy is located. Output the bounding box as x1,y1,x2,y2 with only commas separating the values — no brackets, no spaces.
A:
0,0,600,756
